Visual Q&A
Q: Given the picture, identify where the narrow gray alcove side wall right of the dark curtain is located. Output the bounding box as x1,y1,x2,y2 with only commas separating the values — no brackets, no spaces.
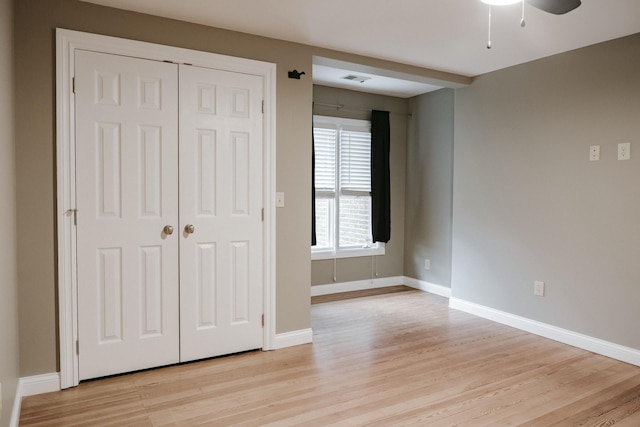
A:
404,89,454,287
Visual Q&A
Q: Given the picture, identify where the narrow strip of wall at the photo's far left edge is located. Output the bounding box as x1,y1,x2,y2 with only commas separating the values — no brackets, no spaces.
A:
0,0,20,427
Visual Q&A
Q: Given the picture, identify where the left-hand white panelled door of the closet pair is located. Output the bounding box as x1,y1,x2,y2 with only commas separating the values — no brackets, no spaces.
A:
75,51,179,380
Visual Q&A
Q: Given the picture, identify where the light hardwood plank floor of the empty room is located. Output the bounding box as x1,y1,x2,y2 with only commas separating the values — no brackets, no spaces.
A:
20,287,640,427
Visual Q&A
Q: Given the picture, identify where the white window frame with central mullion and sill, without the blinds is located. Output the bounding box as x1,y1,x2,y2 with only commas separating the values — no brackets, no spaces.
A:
311,115,385,260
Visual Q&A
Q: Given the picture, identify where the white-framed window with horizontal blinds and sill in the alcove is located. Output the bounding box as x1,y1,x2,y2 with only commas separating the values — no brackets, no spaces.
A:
312,116,384,259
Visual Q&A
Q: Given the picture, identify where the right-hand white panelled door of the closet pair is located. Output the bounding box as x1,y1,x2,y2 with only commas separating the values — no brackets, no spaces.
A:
180,65,263,362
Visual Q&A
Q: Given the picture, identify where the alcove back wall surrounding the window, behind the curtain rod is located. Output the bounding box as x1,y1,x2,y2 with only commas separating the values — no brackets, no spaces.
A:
311,85,408,285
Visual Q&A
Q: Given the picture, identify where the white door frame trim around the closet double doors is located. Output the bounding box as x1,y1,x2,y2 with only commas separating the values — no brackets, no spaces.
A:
56,28,276,389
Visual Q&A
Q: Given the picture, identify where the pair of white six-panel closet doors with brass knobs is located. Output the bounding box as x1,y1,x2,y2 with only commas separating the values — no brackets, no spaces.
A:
75,51,263,380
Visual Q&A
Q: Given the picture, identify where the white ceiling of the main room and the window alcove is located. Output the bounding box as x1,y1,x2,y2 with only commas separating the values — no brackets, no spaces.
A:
80,0,640,97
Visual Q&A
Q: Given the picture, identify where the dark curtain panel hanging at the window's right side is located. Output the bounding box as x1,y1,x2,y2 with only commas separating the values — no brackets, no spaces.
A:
371,110,391,243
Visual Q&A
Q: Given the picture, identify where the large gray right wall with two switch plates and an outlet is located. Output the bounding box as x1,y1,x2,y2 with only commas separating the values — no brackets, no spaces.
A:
452,34,640,349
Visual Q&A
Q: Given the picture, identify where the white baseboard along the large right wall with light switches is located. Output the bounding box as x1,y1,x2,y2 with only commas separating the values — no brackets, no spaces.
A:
449,298,640,366
